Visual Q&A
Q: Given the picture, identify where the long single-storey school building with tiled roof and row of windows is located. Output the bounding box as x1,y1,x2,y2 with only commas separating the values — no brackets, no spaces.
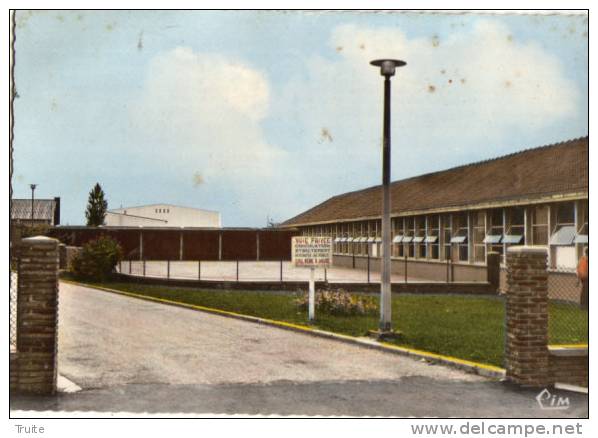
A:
281,137,589,280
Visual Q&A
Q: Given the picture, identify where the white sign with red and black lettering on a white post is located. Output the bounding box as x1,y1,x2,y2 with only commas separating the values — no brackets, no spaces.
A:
291,236,332,321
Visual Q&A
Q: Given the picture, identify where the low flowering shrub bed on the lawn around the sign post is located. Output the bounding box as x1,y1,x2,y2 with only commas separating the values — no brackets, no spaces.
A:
295,289,378,316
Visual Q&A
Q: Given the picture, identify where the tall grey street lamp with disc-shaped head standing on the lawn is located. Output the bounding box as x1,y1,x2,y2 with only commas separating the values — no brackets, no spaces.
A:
370,59,407,337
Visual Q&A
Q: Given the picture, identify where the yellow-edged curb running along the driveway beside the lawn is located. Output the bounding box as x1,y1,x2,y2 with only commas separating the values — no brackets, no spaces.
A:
60,279,505,379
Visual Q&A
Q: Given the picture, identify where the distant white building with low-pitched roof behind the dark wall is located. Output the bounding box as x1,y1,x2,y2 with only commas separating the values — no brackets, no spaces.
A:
104,204,222,228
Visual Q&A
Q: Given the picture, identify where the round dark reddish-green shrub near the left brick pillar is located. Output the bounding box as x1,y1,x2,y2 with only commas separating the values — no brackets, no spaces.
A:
70,237,122,282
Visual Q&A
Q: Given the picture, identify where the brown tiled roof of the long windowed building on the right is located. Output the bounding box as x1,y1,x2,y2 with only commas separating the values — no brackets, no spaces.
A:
282,137,588,226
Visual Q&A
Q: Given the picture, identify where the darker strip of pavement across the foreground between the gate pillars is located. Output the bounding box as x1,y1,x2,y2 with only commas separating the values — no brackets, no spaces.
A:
10,377,588,418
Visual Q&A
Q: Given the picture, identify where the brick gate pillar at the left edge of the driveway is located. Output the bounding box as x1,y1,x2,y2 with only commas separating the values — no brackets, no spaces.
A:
16,236,59,394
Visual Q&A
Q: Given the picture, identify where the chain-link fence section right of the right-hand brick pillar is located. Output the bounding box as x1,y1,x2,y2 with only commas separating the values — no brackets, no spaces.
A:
548,268,588,345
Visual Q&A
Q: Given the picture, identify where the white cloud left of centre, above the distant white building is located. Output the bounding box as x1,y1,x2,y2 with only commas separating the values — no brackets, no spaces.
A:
131,47,284,180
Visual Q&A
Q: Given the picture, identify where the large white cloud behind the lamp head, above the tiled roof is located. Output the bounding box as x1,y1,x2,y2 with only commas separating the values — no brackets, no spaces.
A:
279,20,580,181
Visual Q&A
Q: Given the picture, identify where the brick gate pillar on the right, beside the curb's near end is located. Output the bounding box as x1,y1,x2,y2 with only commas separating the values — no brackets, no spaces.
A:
505,246,550,387
